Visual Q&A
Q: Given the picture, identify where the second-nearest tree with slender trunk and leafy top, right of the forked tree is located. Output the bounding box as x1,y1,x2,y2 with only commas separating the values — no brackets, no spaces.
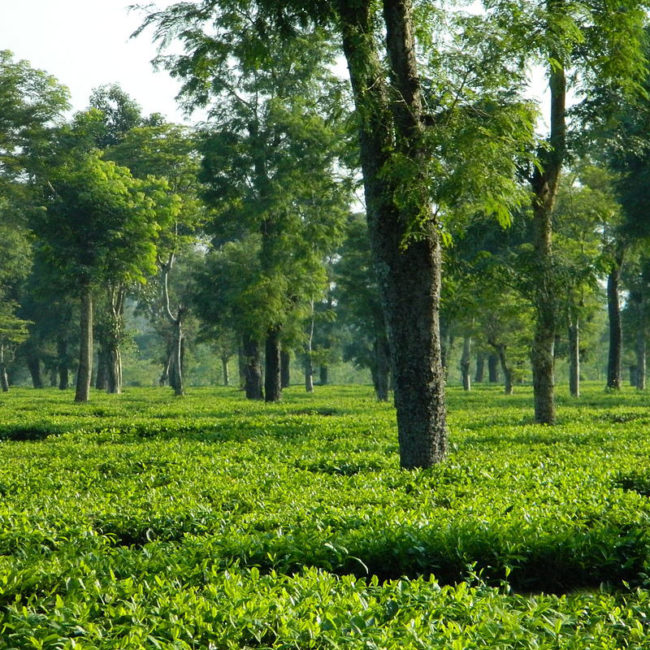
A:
484,0,646,424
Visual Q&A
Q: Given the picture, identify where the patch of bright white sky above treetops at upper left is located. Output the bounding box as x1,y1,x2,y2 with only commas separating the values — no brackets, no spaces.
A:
0,0,184,122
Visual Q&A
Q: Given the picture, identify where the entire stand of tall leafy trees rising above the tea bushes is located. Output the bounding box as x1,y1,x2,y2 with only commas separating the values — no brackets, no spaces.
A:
0,0,650,468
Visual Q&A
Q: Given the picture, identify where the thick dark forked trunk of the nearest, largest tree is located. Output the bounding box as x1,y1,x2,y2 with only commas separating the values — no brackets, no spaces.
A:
337,0,447,468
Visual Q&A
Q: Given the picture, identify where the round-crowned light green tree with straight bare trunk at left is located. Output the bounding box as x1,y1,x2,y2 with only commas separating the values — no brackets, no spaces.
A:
34,154,177,402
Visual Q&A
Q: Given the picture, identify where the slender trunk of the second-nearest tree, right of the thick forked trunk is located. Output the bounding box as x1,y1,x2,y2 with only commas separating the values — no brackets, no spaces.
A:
531,16,567,424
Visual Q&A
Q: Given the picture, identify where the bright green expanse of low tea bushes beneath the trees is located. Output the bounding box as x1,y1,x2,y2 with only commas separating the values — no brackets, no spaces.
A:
0,386,650,648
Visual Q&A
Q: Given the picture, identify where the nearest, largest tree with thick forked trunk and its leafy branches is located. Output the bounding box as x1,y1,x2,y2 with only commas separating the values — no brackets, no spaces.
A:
137,0,532,468
